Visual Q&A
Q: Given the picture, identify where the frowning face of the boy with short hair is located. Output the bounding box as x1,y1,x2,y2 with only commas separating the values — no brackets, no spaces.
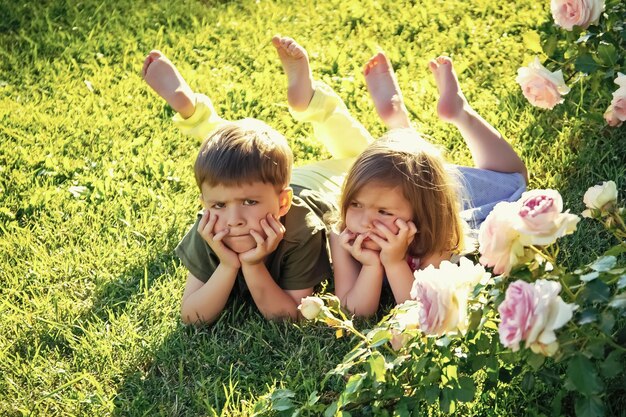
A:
200,182,292,253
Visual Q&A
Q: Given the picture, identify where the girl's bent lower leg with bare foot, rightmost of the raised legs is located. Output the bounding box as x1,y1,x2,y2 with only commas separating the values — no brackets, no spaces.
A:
428,56,528,179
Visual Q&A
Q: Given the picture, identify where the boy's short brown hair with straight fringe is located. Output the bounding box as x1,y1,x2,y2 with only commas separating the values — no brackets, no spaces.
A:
194,119,293,191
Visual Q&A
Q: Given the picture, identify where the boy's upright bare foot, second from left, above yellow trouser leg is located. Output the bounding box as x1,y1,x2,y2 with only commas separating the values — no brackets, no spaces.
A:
272,36,315,111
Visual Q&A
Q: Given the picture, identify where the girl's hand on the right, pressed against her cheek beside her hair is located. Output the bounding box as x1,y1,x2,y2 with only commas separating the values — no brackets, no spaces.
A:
370,219,417,266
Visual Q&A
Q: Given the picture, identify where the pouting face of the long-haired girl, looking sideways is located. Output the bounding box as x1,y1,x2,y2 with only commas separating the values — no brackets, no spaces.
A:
345,183,413,251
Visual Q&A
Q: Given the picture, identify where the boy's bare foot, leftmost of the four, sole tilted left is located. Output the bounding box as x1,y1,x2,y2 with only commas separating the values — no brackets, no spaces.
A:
141,50,195,119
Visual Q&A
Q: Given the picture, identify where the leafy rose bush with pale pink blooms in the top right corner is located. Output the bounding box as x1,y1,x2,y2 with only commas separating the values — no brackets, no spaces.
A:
517,0,626,127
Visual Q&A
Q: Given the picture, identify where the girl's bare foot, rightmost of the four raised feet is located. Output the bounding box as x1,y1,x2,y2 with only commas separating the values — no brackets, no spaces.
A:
428,56,469,123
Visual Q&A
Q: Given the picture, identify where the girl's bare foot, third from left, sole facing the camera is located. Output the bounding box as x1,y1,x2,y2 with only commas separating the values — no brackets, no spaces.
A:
363,52,411,129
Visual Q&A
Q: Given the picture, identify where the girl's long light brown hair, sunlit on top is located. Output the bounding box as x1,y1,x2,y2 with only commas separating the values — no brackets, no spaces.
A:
339,129,463,259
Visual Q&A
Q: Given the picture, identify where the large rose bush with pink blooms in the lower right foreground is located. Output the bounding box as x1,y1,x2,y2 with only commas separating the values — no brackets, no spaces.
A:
256,181,626,416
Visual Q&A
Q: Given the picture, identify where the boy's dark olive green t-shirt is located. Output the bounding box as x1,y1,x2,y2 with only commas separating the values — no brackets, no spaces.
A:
176,186,336,290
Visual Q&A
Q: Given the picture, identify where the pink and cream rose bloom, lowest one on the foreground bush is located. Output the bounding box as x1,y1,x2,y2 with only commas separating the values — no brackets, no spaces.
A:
498,279,574,356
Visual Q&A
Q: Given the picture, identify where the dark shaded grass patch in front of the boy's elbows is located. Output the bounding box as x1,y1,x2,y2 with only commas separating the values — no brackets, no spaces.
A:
113,296,352,416
